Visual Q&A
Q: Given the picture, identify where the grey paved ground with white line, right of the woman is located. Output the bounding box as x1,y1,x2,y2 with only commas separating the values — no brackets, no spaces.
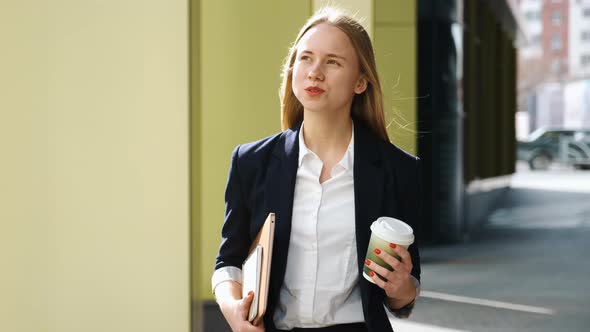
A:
392,168,590,332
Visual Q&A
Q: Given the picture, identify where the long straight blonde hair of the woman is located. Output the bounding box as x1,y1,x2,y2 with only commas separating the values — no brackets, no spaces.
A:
279,7,389,142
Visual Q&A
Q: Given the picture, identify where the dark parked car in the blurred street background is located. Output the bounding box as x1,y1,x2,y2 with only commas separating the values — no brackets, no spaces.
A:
517,128,590,170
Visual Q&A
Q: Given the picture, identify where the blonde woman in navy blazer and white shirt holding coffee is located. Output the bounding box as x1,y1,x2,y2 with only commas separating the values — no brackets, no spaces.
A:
212,9,420,332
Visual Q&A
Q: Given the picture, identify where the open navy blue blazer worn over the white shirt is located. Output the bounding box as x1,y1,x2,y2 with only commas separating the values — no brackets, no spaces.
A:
215,121,421,332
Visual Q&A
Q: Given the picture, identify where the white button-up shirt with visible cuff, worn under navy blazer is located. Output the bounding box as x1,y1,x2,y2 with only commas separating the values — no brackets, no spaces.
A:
212,125,364,330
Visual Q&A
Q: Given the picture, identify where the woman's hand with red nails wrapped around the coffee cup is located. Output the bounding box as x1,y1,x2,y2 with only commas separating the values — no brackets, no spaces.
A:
365,243,416,309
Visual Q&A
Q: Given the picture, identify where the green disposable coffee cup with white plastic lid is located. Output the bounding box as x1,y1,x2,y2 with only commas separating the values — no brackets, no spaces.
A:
363,217,414,283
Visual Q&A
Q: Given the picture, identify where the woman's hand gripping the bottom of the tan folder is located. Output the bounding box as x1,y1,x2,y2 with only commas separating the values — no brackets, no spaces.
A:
219,286,264,332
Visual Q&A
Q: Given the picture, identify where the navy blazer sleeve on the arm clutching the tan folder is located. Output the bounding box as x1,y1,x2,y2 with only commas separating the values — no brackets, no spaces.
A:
215,145,250,270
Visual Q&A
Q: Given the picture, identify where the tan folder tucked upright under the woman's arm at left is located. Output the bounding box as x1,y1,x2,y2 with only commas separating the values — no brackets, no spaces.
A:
249,212,275,325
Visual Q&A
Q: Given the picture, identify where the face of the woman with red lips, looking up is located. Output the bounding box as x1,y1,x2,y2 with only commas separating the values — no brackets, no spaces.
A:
292,23,366,114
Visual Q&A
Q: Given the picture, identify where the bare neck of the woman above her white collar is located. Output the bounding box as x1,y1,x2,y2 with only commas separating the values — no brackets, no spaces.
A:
303,111,352,157
